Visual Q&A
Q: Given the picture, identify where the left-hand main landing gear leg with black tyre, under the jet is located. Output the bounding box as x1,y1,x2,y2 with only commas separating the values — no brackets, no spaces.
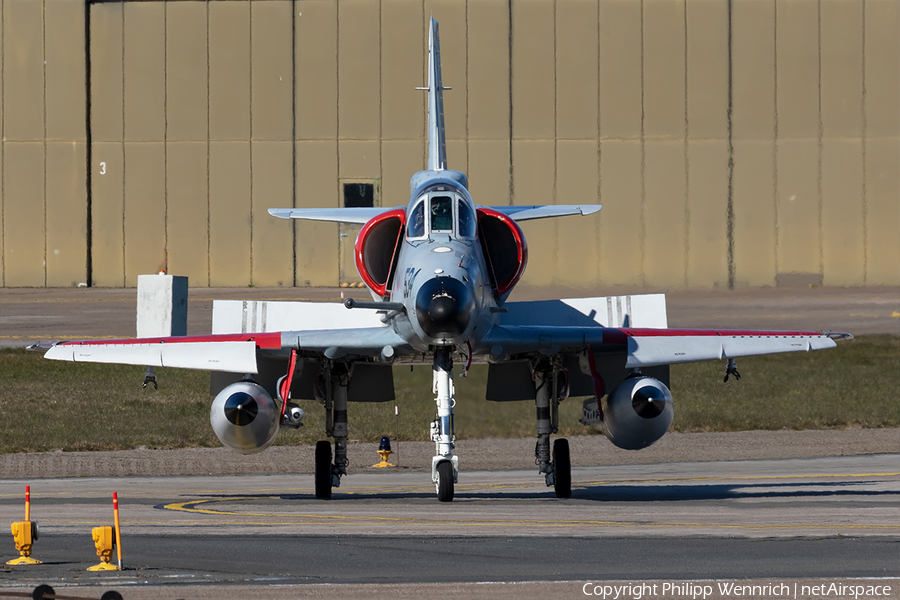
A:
315,364,350,499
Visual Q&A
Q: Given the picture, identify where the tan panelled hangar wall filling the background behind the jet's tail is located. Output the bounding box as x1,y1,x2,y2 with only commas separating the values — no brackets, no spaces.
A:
0,0,900,289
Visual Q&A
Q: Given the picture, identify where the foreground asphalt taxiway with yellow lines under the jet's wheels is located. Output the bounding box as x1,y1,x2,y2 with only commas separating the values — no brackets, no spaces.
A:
0,454,900,598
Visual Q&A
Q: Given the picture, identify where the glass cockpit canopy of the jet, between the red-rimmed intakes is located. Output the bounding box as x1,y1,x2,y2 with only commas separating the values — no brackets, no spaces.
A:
406,190,478,240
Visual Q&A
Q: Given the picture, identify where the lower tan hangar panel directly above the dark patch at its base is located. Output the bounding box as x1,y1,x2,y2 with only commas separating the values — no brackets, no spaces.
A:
777,140,821,278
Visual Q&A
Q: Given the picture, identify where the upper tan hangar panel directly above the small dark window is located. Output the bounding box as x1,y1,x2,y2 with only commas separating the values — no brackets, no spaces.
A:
338,0,382,139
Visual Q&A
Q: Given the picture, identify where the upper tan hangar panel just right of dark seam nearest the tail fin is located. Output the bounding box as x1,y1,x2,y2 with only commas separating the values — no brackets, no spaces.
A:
510,0,556,138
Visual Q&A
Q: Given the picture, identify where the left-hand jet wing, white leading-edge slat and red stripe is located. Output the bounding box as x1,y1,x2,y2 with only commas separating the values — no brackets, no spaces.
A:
32,327,407,374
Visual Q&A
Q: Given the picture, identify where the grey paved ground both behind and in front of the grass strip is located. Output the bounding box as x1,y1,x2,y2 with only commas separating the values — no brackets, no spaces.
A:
0,288,900,600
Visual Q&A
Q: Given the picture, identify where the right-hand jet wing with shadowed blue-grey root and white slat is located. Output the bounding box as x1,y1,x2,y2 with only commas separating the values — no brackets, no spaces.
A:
476,326,853,368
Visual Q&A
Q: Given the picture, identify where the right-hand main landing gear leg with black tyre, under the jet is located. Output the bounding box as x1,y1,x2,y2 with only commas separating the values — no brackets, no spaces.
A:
534,361,572,498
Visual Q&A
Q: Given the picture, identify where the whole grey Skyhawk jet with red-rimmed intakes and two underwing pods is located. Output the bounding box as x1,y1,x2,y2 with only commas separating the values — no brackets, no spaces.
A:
33,19,848,502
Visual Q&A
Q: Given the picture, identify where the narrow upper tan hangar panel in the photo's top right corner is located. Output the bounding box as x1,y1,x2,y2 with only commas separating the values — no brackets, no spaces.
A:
864,0,900,139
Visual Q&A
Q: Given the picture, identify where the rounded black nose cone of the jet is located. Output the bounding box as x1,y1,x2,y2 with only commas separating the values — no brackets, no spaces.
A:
416,277,475,338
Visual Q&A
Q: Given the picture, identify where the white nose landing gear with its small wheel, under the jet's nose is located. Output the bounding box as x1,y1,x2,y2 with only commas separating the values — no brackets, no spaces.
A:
431,346,459,502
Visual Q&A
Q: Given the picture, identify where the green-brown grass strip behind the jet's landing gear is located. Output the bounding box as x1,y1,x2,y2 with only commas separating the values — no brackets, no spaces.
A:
0,335,900,453
